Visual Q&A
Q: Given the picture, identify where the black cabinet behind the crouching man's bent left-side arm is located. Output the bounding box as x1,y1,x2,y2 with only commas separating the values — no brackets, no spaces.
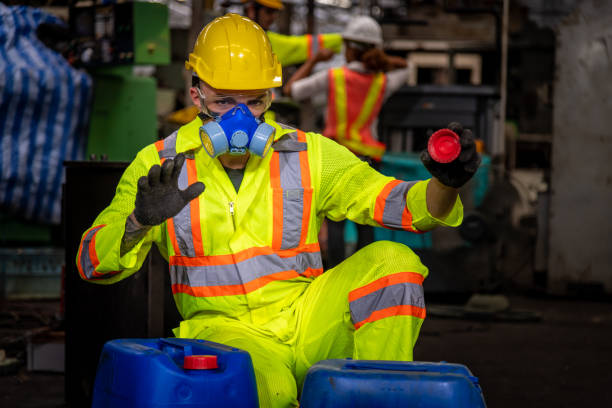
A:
62,161,180,408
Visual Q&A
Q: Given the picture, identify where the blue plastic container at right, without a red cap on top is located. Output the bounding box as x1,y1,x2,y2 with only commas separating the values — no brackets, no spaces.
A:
300,359,486,408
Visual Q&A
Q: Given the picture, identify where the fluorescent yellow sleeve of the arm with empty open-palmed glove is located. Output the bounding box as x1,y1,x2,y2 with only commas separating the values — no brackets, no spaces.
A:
76,146,167,284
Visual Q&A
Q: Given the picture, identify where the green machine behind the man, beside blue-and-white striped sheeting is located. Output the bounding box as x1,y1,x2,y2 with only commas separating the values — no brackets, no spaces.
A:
70,2,170,161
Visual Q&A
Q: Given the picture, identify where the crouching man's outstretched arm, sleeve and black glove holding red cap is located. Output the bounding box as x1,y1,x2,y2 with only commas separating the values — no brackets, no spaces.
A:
313,123,480,233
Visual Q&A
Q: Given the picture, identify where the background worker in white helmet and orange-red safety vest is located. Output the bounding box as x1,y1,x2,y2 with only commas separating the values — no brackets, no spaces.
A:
283,16,409,267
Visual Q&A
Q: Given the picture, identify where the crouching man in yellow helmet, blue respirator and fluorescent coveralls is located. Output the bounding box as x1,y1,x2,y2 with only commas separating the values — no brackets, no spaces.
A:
77,14,479,407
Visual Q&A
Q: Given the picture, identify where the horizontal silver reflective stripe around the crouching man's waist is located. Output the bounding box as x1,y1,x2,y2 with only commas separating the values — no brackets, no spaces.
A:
170,252,323,287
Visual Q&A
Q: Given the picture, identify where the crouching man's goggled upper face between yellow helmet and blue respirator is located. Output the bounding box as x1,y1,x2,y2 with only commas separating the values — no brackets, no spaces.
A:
191,81,272,118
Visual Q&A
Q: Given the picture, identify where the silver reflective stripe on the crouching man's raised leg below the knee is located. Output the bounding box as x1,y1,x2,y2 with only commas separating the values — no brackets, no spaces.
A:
349,282,425,324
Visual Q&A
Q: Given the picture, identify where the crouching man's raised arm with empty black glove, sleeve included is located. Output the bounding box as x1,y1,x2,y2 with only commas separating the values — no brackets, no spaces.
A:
76,145,203,284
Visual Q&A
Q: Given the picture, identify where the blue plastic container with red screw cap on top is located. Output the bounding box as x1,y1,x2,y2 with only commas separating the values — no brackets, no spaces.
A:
92,339,259,408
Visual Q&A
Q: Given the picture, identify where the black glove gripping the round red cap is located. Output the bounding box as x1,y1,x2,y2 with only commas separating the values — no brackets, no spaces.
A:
421,122,480,188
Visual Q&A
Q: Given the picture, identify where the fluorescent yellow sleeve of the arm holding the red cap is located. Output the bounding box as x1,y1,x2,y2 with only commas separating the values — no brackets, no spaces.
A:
309,133,463,233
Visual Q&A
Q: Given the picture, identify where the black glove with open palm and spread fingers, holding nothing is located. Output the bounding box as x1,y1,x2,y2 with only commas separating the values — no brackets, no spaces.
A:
134,153,204,225
